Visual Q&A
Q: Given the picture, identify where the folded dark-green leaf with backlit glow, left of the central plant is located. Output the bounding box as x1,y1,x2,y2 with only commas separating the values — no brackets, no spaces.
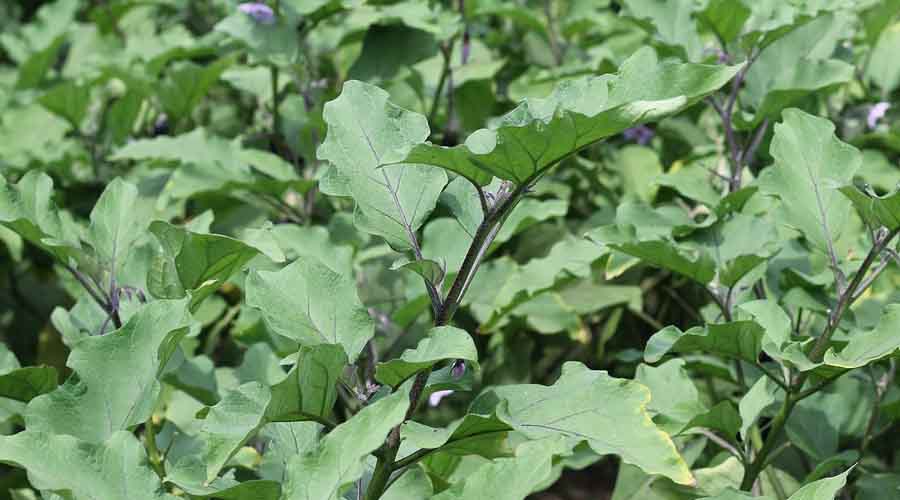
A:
147,221,259,309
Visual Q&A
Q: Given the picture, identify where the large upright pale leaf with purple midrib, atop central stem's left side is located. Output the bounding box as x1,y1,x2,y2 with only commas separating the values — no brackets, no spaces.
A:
317,81,447,249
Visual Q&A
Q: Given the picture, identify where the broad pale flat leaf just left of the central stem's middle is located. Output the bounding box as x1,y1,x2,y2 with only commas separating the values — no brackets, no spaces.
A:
245,257,375,361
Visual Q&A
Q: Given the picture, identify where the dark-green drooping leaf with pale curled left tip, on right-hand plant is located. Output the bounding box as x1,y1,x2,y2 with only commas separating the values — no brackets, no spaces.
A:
644,321,765,363
